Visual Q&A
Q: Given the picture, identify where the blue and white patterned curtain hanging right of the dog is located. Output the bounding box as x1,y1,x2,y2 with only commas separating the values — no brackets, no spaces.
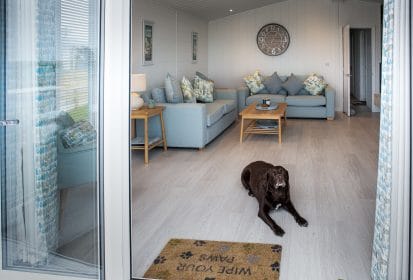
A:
371,0,394,280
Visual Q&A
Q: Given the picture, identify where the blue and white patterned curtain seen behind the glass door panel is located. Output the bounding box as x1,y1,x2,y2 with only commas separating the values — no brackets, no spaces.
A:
5,0,59,267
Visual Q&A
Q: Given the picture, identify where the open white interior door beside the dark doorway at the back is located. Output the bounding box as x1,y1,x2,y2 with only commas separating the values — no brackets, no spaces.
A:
343,25,351,117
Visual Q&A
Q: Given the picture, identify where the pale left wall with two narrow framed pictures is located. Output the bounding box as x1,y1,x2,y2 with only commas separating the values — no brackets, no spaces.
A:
131,0,208,89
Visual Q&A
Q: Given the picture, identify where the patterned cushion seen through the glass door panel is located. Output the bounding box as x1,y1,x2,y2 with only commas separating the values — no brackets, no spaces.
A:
60,121,96,149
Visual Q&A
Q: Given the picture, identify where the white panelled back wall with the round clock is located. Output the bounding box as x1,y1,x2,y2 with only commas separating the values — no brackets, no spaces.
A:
208,0,381,111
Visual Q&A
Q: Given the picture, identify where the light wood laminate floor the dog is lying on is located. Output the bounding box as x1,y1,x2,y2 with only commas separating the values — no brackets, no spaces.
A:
132,113,379,280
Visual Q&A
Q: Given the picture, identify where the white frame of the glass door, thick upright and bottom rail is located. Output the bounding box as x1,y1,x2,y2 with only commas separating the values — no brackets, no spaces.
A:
0,0,130,280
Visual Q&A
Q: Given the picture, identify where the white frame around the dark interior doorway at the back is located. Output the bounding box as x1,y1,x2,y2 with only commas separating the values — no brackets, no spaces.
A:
341,25,381,112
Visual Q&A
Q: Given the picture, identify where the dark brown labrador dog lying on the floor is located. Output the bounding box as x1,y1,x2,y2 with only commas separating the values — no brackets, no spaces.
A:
241,161,308,236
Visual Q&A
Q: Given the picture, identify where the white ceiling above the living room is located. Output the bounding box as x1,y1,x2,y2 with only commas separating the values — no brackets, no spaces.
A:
159,0,383,20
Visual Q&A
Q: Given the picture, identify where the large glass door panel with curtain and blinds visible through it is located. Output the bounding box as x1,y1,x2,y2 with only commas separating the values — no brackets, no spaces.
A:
0,0,103,279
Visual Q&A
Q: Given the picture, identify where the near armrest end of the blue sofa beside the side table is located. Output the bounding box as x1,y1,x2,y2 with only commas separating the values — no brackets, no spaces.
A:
136,103,206,148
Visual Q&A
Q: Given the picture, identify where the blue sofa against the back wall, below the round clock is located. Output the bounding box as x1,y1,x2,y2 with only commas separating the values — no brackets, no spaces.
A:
237,75,335,120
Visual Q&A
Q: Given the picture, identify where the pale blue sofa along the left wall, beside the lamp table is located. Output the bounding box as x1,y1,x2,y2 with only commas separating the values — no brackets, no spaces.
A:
136,88,238,149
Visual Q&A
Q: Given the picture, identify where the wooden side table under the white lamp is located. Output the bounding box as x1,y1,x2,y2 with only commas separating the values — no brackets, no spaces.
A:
131,106,168,165
